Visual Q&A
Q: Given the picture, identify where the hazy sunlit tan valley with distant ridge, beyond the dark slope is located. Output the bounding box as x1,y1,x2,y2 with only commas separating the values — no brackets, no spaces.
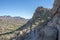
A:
0,16,27,34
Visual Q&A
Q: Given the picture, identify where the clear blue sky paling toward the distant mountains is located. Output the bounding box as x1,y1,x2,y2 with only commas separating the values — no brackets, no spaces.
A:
0,0,54,19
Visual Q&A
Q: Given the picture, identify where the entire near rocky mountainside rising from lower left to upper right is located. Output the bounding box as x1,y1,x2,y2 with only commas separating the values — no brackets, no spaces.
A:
0,0,60,40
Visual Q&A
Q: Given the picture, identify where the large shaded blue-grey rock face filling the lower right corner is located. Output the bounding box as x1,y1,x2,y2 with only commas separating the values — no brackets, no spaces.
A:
31,14,60,40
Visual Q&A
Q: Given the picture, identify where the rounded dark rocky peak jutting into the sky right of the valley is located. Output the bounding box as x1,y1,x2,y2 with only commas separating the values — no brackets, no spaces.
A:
32,7,51,19
